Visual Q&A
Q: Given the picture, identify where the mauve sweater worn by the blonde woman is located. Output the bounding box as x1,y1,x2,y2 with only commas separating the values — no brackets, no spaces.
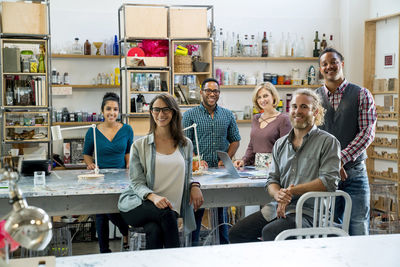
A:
242,114,292,165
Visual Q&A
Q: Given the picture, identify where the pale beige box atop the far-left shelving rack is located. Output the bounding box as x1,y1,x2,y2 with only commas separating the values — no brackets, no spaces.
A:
1,2,49,35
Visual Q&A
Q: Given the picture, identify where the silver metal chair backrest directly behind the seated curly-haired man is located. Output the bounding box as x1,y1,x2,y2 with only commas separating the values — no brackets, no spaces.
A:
296,190,351,233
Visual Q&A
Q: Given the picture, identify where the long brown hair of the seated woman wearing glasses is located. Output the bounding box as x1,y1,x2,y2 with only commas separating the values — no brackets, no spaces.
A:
149,93,187,146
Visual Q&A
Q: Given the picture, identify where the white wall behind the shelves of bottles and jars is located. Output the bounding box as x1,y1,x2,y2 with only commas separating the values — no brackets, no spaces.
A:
51,0,400,159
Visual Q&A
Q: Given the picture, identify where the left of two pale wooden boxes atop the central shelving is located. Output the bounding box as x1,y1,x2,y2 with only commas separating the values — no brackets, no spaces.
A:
125,6,168,39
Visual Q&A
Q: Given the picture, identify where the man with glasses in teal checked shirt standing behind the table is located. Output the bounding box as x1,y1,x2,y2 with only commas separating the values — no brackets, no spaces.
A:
183,78,240,245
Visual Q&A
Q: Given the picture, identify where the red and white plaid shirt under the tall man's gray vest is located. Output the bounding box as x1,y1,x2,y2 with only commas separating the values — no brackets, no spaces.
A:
324,79,376,164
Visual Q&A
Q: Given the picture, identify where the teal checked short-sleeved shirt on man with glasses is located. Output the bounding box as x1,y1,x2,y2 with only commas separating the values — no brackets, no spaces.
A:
183,104,240,167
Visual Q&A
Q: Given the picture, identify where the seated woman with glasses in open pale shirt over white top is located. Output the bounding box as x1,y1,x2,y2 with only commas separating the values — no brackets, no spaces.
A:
118,93,203,249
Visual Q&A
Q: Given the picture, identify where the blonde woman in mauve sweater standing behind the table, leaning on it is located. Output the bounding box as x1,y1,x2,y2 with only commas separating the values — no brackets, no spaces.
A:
234,82,292,168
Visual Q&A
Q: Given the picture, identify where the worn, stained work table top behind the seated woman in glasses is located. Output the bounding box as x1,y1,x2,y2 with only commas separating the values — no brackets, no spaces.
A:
0,168,266,198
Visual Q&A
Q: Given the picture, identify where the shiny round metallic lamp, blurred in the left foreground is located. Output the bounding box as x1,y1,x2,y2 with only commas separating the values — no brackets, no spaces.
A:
0,157,53,262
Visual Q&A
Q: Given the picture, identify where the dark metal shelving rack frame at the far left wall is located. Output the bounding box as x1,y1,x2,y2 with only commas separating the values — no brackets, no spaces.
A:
0,0,52,159
